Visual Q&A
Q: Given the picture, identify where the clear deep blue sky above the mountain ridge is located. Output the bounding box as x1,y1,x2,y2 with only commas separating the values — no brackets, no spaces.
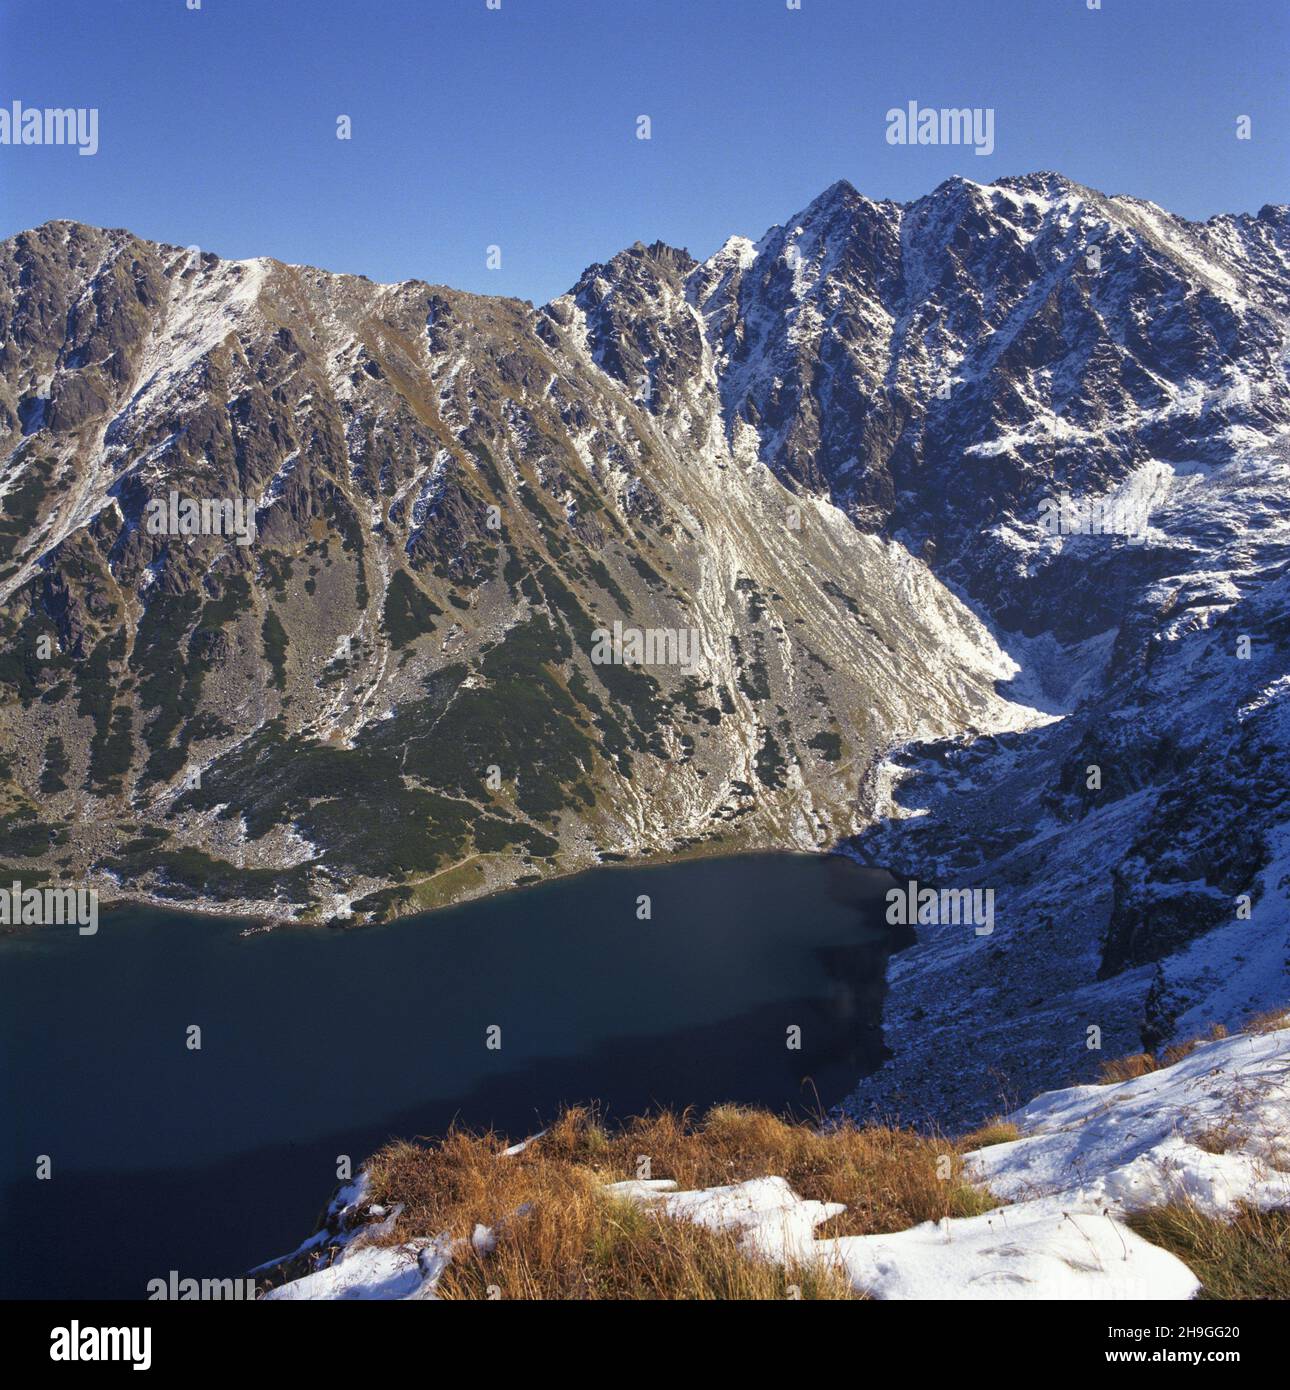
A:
0,0,1290,300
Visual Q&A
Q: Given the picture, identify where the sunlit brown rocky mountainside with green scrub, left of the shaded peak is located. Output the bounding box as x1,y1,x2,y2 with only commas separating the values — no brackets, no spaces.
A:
0,190,1029,919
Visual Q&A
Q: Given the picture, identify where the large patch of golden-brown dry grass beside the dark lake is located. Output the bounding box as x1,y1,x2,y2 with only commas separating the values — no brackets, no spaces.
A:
368,1105,997,1298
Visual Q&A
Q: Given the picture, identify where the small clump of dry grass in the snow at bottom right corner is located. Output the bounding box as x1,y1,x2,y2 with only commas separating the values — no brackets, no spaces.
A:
1127,1202,1290,1300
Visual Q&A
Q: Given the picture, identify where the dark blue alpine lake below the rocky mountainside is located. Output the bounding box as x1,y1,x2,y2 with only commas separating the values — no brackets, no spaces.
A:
0,855,894,1298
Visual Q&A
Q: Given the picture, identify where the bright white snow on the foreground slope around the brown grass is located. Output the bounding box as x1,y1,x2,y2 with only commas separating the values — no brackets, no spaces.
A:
267,1016,1290,1300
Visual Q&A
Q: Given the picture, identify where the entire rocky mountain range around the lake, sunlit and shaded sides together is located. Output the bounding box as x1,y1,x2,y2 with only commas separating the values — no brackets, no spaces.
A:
0,174,1290,1104
